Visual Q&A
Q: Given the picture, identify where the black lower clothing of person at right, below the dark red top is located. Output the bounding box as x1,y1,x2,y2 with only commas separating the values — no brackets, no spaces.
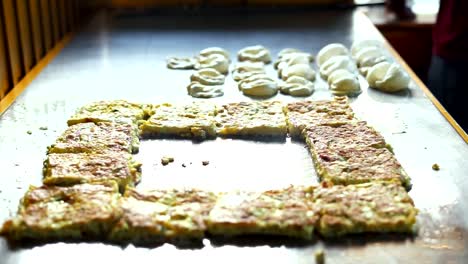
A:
428,55,468,132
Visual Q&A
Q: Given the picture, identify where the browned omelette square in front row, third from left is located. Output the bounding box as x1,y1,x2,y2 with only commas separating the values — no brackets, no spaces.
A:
207,186,318,240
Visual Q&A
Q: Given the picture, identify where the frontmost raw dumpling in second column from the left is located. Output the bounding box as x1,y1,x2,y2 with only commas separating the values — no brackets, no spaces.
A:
239,74,278,97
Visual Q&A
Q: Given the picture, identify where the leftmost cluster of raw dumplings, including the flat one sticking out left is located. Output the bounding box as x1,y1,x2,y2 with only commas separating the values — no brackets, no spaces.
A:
167,47,230,98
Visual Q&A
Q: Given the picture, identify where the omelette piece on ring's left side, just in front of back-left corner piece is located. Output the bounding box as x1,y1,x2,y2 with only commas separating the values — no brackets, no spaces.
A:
48,122,140,153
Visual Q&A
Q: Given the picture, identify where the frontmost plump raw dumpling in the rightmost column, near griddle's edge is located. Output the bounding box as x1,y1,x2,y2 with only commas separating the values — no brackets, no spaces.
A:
367,62,410,93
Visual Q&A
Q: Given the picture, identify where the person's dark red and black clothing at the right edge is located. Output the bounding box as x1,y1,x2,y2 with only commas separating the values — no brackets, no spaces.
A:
428,0,468,131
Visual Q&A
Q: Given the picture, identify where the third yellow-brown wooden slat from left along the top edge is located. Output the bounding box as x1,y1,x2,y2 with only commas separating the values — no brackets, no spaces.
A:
29,0,44,63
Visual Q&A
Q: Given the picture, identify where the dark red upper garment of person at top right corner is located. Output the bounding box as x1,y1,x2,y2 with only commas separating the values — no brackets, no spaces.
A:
433,0,468,60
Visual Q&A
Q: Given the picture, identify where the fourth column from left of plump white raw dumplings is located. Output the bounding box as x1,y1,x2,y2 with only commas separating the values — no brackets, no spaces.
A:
317,43,361,95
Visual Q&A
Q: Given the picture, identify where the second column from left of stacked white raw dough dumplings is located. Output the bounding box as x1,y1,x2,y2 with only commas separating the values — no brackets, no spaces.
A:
232,45,278,97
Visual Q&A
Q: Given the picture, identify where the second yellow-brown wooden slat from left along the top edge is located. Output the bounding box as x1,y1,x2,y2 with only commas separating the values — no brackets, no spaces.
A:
16,1,34,73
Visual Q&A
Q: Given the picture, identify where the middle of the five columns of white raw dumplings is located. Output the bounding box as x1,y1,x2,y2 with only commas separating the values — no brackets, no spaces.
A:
274,48,315,96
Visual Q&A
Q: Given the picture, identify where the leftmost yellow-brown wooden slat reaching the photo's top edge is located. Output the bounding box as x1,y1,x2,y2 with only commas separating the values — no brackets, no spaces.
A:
3,0,23,85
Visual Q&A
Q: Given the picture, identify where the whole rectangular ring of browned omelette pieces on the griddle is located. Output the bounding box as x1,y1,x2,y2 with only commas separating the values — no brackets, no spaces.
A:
2,97,417,243
